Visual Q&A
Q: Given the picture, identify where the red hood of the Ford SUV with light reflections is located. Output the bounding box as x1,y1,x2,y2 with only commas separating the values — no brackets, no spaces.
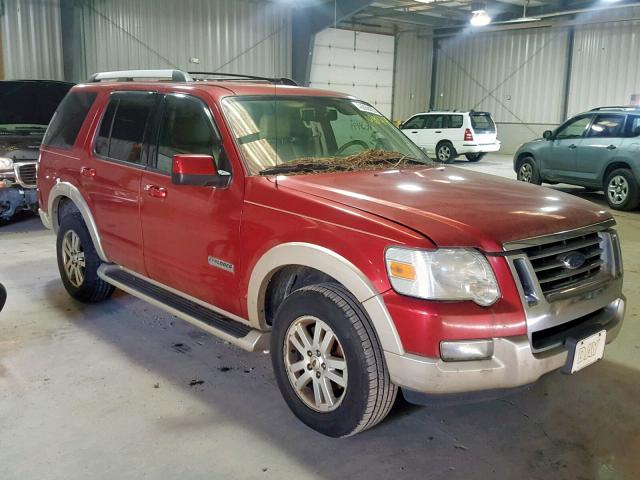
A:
278,167,611,252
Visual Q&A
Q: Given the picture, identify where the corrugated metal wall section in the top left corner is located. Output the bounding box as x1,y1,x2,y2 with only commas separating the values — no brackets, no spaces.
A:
0,0,63,80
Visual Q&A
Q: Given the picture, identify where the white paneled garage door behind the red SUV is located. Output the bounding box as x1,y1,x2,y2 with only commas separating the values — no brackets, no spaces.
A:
310,28,395,118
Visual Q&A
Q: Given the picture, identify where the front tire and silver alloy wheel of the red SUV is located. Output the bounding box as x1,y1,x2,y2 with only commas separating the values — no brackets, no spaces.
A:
271,283,398,437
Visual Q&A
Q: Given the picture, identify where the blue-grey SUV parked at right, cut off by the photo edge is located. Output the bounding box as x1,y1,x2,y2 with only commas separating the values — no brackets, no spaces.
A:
513,107,640,210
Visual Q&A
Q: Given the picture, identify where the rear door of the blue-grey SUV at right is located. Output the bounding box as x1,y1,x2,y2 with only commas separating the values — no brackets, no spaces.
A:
575,113,626,185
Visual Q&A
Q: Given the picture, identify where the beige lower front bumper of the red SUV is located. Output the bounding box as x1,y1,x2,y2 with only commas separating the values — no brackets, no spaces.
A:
385,296,626,394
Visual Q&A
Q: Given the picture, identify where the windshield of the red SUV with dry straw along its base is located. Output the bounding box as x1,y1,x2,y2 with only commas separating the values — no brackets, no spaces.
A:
223,96,433,175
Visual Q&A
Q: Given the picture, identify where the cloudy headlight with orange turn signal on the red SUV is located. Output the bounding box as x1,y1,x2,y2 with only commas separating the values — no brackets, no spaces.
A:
385,247,500,307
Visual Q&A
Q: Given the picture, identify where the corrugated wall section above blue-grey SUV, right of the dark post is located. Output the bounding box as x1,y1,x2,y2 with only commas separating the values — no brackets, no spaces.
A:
568,17,640,115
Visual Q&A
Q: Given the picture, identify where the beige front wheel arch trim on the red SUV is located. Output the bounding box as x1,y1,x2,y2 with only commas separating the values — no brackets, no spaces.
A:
247,242,404,355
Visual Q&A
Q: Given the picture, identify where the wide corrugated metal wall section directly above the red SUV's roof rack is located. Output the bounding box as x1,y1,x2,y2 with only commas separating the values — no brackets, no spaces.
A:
82,0,291,76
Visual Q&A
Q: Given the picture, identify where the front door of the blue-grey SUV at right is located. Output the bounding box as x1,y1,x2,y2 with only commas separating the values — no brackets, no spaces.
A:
540,114,593,181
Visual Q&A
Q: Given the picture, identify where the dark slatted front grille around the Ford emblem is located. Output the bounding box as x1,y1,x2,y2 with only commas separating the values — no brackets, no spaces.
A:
524,232,604,295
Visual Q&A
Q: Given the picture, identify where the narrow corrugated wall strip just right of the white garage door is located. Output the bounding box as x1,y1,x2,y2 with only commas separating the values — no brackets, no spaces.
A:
392,31,433,120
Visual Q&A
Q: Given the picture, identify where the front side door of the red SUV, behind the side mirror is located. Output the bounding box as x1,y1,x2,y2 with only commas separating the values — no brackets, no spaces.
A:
141,94,244,313
